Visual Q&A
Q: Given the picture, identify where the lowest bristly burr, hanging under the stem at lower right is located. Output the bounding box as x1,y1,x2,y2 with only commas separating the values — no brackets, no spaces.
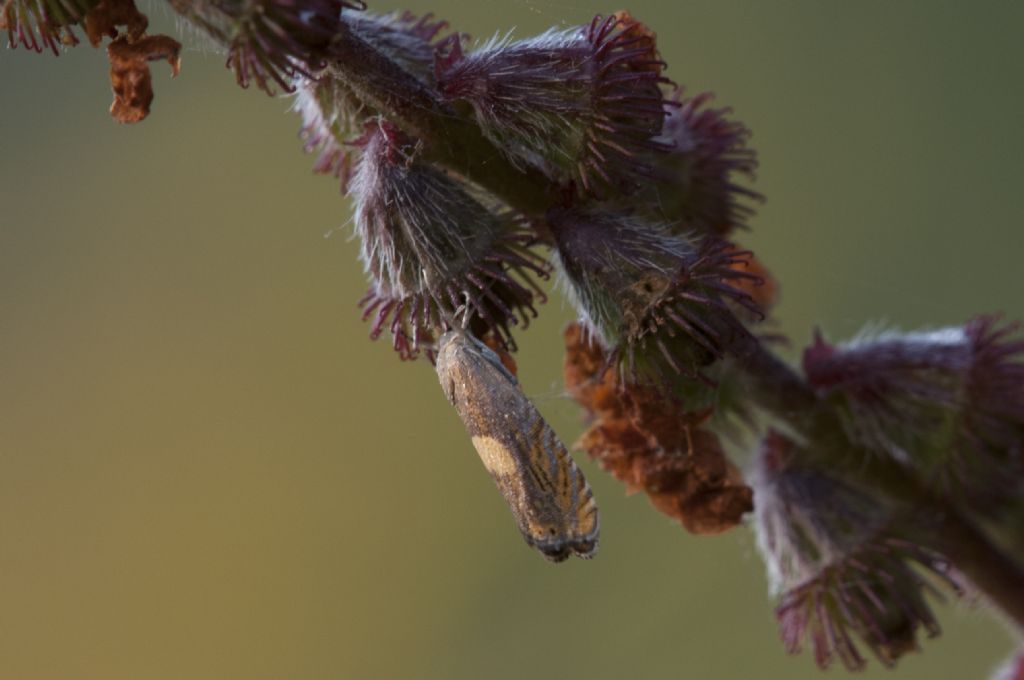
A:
753,432,959,670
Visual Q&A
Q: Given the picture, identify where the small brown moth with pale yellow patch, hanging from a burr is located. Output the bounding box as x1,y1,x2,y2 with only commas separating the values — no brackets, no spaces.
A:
437,330,598,562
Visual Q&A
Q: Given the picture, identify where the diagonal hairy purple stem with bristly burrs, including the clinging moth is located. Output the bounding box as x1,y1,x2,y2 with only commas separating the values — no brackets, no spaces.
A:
0,0,1024,677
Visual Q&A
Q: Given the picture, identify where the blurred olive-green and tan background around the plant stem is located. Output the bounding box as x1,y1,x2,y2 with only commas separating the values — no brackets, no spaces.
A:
0,0,1024,680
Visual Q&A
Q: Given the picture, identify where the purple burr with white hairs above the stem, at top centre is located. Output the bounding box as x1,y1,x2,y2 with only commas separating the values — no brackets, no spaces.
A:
437,13,669,195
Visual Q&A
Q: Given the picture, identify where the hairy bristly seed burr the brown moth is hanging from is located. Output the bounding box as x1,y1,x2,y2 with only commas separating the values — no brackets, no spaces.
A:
352,121,550,358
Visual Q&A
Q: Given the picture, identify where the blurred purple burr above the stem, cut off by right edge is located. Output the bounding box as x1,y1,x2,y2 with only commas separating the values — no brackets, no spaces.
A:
804,316,1024,516
